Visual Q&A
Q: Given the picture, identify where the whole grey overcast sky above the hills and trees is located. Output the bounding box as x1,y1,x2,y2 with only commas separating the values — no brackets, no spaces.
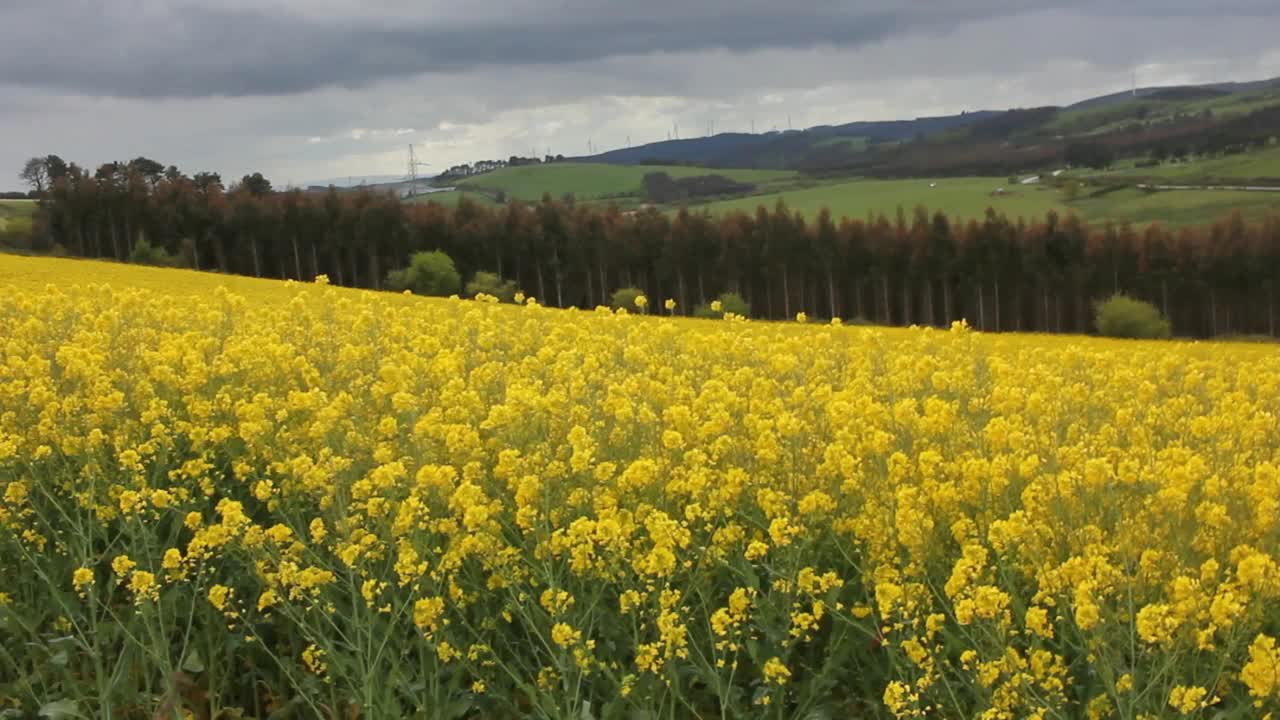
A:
0,0,1280,188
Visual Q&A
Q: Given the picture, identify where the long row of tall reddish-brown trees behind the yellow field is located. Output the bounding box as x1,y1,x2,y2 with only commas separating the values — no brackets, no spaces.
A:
17,159,1280,337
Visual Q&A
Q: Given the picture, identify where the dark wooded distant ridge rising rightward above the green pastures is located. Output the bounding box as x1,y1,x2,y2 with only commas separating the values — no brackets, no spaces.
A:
579,79,1280,177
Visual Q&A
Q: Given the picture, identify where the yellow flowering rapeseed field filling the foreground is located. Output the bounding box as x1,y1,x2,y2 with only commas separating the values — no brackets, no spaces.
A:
0,256,1280,720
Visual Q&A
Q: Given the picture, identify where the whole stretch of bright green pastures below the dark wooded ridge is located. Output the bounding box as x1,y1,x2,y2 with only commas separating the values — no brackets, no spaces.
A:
413,156,1280,225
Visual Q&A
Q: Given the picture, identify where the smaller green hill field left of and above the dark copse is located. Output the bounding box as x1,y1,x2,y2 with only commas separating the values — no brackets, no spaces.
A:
458,163,795,202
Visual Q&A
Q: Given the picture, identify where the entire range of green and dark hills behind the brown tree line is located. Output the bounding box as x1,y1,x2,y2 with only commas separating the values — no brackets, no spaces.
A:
401,74,1280,224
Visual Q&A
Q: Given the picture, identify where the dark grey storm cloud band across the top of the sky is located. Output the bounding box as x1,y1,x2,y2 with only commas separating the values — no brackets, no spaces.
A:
0,0,1280,97
